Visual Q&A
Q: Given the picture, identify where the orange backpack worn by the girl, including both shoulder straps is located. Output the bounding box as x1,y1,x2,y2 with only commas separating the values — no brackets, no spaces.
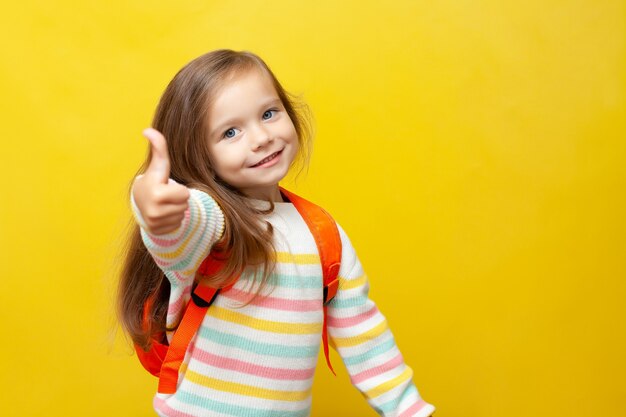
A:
135,187,341,394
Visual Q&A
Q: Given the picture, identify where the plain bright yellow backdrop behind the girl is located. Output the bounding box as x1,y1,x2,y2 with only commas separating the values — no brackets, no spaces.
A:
0,0,626,417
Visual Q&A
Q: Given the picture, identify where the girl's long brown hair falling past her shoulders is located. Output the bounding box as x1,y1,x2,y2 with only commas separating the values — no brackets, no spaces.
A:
117,49,312,350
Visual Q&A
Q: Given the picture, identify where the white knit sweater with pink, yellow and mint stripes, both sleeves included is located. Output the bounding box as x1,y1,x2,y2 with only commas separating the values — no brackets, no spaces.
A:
131,189,435,417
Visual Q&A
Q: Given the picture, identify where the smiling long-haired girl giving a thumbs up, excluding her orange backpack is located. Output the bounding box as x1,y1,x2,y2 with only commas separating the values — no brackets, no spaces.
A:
118,50,435,417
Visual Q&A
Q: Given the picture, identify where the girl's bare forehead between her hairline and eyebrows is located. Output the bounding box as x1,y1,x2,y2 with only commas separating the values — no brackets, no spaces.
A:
209,69,278,118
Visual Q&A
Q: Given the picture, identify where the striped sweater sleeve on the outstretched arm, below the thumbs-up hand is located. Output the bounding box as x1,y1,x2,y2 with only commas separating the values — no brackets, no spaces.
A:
130,177,224,327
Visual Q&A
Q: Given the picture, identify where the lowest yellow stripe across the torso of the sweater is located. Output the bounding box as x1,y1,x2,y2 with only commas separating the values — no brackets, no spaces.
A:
185,369,310,401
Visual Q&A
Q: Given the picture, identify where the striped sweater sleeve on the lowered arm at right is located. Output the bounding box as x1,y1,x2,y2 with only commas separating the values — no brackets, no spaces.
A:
328,227,435,417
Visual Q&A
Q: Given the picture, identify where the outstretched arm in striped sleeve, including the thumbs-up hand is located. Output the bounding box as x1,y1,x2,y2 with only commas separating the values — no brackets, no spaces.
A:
130,129,224,327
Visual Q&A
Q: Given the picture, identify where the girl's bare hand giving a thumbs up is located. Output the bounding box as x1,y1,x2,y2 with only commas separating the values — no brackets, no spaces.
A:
132,128,189,235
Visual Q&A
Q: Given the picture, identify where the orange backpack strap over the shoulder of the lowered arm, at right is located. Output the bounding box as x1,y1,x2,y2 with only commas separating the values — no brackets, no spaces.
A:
280,187,341,375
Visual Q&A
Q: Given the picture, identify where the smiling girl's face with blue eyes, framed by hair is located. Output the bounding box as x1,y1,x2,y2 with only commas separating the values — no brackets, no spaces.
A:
208,70,298,200
